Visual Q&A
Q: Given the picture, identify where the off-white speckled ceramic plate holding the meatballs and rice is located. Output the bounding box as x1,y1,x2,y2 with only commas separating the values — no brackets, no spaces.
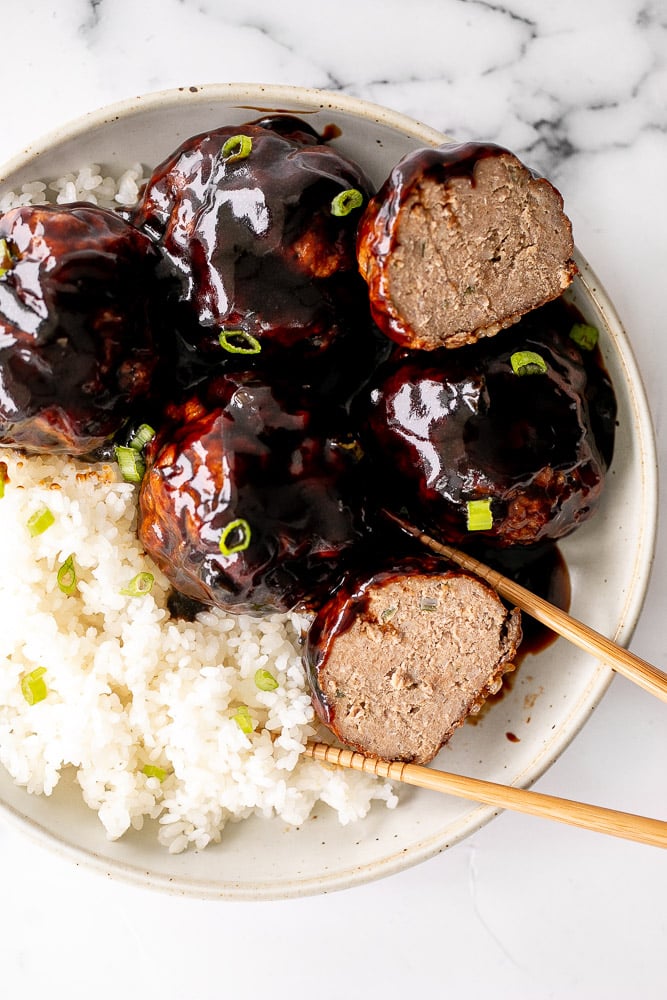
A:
0,84,657,899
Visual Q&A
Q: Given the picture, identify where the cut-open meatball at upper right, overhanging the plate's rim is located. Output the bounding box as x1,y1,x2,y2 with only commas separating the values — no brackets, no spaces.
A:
358,143,576,350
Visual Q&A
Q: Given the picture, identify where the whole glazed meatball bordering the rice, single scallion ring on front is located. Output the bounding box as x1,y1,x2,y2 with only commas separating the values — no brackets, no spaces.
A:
139,372,363,614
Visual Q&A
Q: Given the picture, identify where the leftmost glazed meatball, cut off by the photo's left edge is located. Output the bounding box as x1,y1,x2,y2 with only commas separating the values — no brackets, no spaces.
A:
0,204,159,455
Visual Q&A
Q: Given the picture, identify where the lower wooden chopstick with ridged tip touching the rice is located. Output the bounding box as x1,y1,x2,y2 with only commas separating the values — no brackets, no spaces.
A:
305,742,667,847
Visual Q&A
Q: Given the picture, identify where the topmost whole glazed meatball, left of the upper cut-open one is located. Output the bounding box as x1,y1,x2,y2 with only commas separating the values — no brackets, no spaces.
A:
134,116,368,363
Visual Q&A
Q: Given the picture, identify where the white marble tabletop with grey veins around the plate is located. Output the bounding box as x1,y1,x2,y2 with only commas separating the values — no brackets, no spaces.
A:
0,0,667,1000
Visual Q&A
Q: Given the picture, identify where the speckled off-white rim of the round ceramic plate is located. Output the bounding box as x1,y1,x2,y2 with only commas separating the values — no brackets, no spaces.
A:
0,82,658,901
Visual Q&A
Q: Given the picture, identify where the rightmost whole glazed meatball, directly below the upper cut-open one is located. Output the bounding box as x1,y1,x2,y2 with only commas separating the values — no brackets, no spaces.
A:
366,303,615,546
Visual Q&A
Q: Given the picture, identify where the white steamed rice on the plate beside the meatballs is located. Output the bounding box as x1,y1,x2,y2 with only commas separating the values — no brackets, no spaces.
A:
0,164,397,853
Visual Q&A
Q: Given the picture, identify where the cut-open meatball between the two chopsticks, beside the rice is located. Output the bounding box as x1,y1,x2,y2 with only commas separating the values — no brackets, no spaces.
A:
305,557,521,763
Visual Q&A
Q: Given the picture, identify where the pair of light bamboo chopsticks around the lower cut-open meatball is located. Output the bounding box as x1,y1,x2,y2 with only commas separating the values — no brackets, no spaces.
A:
306,511,667,847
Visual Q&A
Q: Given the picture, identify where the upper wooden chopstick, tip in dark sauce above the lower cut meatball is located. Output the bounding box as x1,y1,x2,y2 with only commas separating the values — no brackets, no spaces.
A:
383,510,667,701
